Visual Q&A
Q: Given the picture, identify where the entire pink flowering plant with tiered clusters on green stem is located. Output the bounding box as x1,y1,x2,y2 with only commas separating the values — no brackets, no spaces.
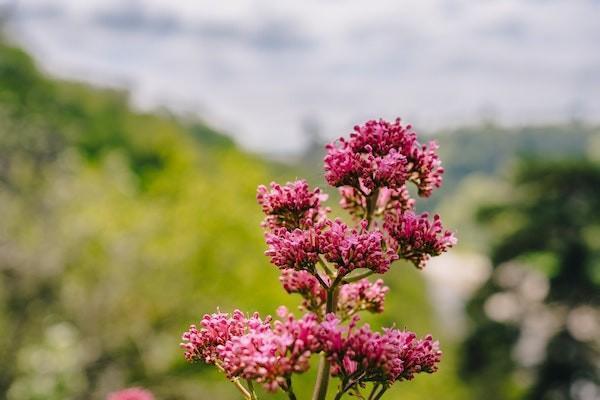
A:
181,119,456,400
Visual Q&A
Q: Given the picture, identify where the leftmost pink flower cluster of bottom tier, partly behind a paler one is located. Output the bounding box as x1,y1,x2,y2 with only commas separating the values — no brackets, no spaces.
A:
180,310,270,364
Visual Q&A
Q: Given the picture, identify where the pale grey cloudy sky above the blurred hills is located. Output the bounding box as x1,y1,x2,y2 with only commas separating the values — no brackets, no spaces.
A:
0,0,600,154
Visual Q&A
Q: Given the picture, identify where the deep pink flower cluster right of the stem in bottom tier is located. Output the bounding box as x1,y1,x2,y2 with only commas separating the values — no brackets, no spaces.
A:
317,314,442,385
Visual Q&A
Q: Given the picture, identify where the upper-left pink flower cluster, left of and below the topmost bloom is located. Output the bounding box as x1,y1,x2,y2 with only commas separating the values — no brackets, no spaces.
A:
256,180,328,230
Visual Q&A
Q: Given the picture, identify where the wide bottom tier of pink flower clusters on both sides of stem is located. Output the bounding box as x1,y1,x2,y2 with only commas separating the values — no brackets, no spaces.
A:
180,310,441,394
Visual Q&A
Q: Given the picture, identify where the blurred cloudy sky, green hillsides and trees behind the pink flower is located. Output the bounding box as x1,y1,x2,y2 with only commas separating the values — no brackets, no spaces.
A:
0,0,600,400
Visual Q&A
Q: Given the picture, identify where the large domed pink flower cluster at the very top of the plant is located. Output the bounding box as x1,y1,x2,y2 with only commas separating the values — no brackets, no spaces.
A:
324,118,444,196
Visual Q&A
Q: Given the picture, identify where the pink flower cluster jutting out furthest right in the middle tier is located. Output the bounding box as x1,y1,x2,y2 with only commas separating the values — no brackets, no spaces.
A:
384,211,457,268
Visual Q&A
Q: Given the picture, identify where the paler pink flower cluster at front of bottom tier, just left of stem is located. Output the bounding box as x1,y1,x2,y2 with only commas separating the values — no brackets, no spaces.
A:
219,314,321,391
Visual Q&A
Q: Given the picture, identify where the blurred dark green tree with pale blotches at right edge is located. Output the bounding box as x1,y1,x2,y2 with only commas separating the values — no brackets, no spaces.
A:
462,159,600,400
